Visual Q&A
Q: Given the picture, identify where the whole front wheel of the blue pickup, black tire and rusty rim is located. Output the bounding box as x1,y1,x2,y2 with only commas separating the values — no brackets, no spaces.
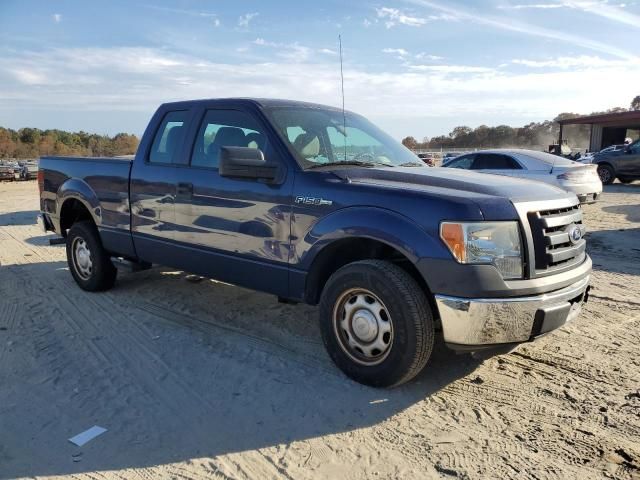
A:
320,260,434,387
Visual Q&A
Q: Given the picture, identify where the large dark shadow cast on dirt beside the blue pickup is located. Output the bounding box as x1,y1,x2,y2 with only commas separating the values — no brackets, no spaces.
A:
0,261,480,478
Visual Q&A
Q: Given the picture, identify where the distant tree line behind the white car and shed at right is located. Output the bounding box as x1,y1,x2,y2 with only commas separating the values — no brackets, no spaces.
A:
402,95,640,150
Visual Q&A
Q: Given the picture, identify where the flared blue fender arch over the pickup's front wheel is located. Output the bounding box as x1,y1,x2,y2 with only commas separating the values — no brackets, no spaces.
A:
293,207,449,271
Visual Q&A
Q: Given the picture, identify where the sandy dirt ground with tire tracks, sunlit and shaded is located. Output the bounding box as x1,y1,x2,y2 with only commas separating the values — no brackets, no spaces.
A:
0,182,640,479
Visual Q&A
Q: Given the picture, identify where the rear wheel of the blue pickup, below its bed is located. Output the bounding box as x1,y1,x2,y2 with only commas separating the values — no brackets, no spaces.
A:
67,221,118,292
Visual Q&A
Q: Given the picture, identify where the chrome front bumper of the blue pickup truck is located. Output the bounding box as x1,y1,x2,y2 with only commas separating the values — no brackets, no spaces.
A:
435,275,590,350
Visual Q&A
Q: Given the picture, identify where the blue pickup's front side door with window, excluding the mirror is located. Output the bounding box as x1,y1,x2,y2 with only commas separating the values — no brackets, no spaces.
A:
175,108,293,296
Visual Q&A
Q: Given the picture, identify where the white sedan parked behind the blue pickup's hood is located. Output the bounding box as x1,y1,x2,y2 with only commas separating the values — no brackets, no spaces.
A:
442,149,602,203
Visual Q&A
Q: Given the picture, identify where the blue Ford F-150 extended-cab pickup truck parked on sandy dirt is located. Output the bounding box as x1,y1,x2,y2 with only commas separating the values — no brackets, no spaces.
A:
38,99,591,387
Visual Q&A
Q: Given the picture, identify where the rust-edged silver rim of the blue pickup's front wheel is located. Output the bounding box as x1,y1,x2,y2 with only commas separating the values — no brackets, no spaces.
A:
333,289,393,365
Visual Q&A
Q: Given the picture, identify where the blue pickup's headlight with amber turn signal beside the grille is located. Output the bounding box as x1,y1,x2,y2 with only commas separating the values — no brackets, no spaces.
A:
440,222,522,279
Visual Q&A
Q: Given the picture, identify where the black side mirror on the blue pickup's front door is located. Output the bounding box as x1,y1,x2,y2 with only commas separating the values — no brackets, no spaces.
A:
218,147,278,182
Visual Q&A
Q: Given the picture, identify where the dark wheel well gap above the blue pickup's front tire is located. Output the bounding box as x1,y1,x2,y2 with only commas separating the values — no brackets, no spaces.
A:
305,238,437,313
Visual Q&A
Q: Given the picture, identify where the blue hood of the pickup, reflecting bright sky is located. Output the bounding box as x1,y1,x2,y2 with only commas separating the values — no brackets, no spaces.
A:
333,167,571,202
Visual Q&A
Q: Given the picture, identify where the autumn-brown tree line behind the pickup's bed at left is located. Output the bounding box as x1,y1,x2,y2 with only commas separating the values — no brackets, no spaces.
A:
0,127,139,159
